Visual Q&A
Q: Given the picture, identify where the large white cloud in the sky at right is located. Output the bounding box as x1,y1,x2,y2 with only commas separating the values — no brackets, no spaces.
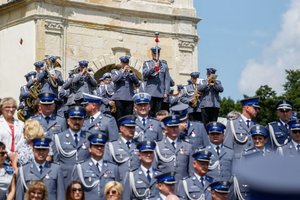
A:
239,0,300,95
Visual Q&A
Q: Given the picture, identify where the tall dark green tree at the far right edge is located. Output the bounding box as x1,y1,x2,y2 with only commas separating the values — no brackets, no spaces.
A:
283,70,300,112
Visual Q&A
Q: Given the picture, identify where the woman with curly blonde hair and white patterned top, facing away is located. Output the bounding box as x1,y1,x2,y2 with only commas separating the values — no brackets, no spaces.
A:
17,120,45,165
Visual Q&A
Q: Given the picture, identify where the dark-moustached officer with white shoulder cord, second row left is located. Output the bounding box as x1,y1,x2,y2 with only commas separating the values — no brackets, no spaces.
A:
53,106,90,186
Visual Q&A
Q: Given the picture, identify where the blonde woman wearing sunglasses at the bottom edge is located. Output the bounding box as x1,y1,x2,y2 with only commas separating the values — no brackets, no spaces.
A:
104,181,123,200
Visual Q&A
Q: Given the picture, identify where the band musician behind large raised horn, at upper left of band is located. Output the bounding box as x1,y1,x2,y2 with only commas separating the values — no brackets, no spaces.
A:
36,56,64,96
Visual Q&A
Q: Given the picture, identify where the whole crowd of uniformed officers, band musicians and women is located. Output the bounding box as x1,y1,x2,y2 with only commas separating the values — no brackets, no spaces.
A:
0,46,300,200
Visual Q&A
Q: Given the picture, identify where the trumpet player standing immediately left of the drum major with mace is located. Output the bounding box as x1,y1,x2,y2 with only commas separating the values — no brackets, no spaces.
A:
111,56,139,119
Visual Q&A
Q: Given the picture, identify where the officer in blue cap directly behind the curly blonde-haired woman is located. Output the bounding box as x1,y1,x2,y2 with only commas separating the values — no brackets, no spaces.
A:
31,93,67,138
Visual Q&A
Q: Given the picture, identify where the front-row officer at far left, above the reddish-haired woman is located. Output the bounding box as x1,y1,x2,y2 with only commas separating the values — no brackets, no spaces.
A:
16,138,65,200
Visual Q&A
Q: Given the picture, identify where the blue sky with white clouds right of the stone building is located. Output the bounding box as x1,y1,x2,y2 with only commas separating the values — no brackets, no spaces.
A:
194,0,300,100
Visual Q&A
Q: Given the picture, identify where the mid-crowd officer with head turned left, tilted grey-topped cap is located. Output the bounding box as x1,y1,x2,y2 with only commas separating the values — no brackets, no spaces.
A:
170,104,209,150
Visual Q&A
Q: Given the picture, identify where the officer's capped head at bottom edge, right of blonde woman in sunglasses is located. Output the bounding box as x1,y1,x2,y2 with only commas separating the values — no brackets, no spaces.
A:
149,172,177,200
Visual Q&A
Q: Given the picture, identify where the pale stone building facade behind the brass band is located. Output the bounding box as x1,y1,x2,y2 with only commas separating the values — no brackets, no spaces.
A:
0,0,199,98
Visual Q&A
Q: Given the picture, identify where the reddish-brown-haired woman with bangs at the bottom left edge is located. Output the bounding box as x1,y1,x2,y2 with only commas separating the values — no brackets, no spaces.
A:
24,181,48,200
